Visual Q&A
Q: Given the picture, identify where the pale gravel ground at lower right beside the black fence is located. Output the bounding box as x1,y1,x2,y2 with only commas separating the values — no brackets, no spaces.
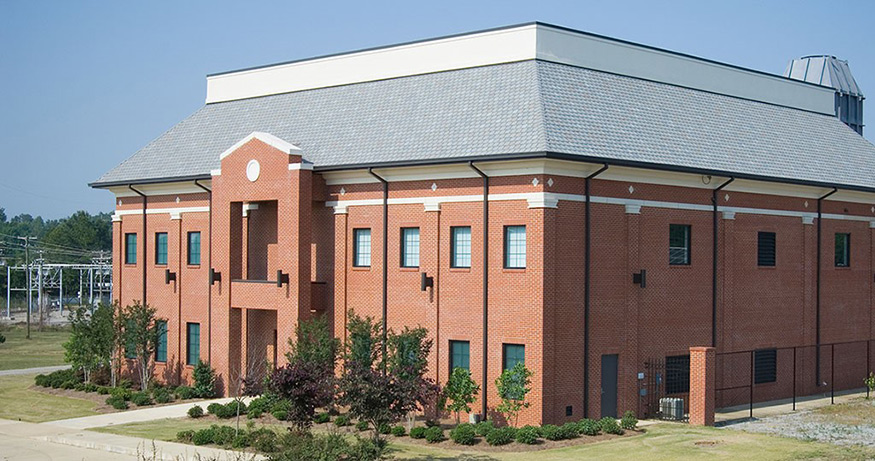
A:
726,402,875,447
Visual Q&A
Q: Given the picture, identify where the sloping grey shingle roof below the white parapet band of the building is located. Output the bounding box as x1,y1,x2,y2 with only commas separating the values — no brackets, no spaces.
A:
94,61,875,189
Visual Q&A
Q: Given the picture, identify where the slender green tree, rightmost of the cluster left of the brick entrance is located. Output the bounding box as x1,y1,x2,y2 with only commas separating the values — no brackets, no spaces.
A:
124,301,163,391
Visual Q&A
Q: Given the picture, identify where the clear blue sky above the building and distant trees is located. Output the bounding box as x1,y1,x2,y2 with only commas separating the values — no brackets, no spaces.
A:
0,0,875,218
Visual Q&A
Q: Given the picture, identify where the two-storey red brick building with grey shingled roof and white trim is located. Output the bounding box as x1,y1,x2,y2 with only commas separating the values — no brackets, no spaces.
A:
92,23,875,422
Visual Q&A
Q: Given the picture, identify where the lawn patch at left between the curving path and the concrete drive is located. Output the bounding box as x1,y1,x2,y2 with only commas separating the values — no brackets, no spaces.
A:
0,375,98,423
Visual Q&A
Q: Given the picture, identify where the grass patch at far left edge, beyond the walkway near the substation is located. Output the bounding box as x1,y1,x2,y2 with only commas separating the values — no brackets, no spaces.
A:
0,325,70,370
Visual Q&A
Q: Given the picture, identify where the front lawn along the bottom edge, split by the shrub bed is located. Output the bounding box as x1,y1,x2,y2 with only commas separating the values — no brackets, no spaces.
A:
95,418,875,461
